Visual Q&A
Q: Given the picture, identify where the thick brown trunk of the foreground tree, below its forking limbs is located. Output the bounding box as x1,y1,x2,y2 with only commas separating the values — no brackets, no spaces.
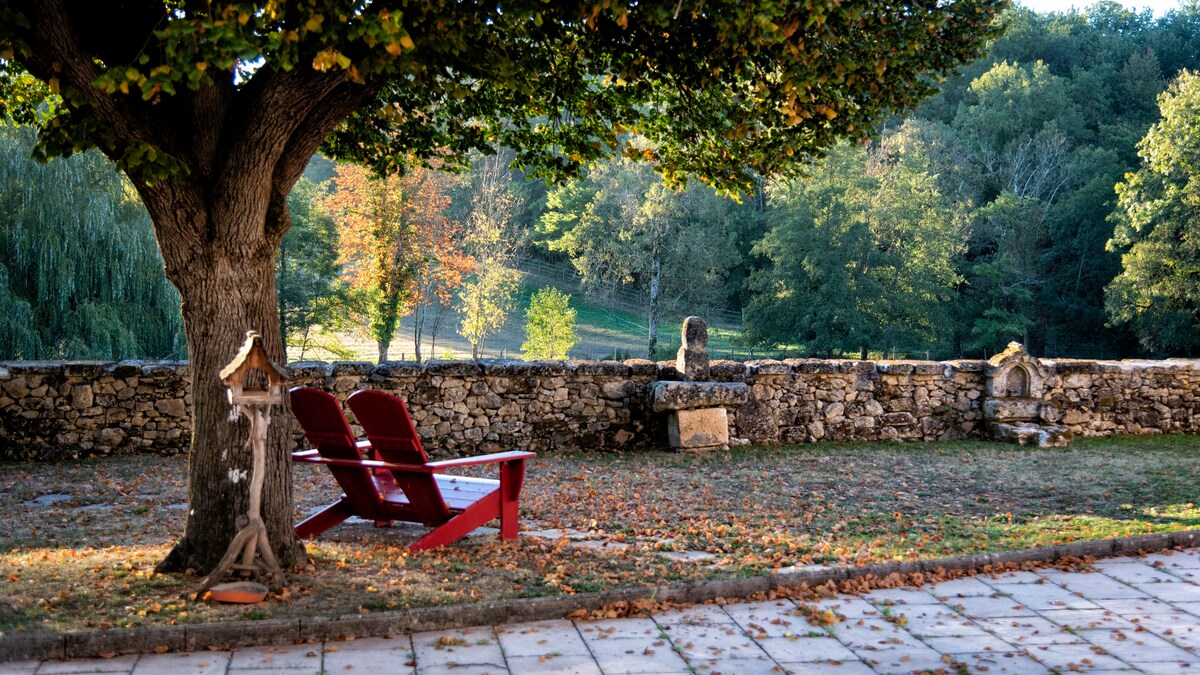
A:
155,196,304,566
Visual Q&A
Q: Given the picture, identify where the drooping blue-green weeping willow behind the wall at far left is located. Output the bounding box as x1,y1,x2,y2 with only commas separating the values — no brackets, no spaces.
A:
0,125,185,359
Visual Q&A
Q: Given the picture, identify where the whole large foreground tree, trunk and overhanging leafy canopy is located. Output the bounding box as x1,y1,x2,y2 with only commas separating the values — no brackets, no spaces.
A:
0,0,1006,571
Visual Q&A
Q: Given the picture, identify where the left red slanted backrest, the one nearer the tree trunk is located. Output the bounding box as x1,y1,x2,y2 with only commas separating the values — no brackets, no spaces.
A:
288,387,383,518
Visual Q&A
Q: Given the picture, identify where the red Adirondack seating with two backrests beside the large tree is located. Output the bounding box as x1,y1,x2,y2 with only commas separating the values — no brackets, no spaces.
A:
290,387,536,551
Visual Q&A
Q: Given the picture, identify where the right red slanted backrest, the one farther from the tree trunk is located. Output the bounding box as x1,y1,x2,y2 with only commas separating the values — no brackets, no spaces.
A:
346,389,450,525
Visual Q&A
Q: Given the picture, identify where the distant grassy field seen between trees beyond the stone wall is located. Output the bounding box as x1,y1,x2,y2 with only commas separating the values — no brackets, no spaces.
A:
288,257,782,362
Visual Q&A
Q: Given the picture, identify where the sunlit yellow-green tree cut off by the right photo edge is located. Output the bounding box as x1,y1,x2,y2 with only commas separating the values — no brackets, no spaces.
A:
1108,71,1200,354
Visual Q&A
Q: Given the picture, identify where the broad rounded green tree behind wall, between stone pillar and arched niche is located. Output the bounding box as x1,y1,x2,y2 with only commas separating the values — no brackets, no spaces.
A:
746,128,961,358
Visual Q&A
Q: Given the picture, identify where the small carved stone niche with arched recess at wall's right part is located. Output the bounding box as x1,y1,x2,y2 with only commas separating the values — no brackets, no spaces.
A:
983,342,1073,448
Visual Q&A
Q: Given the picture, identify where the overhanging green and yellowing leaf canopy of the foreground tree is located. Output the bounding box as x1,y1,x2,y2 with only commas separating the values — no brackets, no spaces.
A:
0,0,1003,192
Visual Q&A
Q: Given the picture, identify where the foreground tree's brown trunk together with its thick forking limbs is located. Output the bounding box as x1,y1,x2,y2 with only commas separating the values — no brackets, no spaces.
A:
8,0,374,573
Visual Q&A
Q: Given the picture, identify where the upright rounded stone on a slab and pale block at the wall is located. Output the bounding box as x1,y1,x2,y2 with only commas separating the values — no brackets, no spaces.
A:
649,316,750,453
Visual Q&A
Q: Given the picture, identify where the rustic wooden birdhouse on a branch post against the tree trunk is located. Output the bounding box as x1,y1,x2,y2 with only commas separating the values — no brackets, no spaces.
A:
194,330,295,597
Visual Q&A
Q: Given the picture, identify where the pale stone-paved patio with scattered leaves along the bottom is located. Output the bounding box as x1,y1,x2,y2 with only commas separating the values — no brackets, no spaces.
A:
7,549,1200,675
